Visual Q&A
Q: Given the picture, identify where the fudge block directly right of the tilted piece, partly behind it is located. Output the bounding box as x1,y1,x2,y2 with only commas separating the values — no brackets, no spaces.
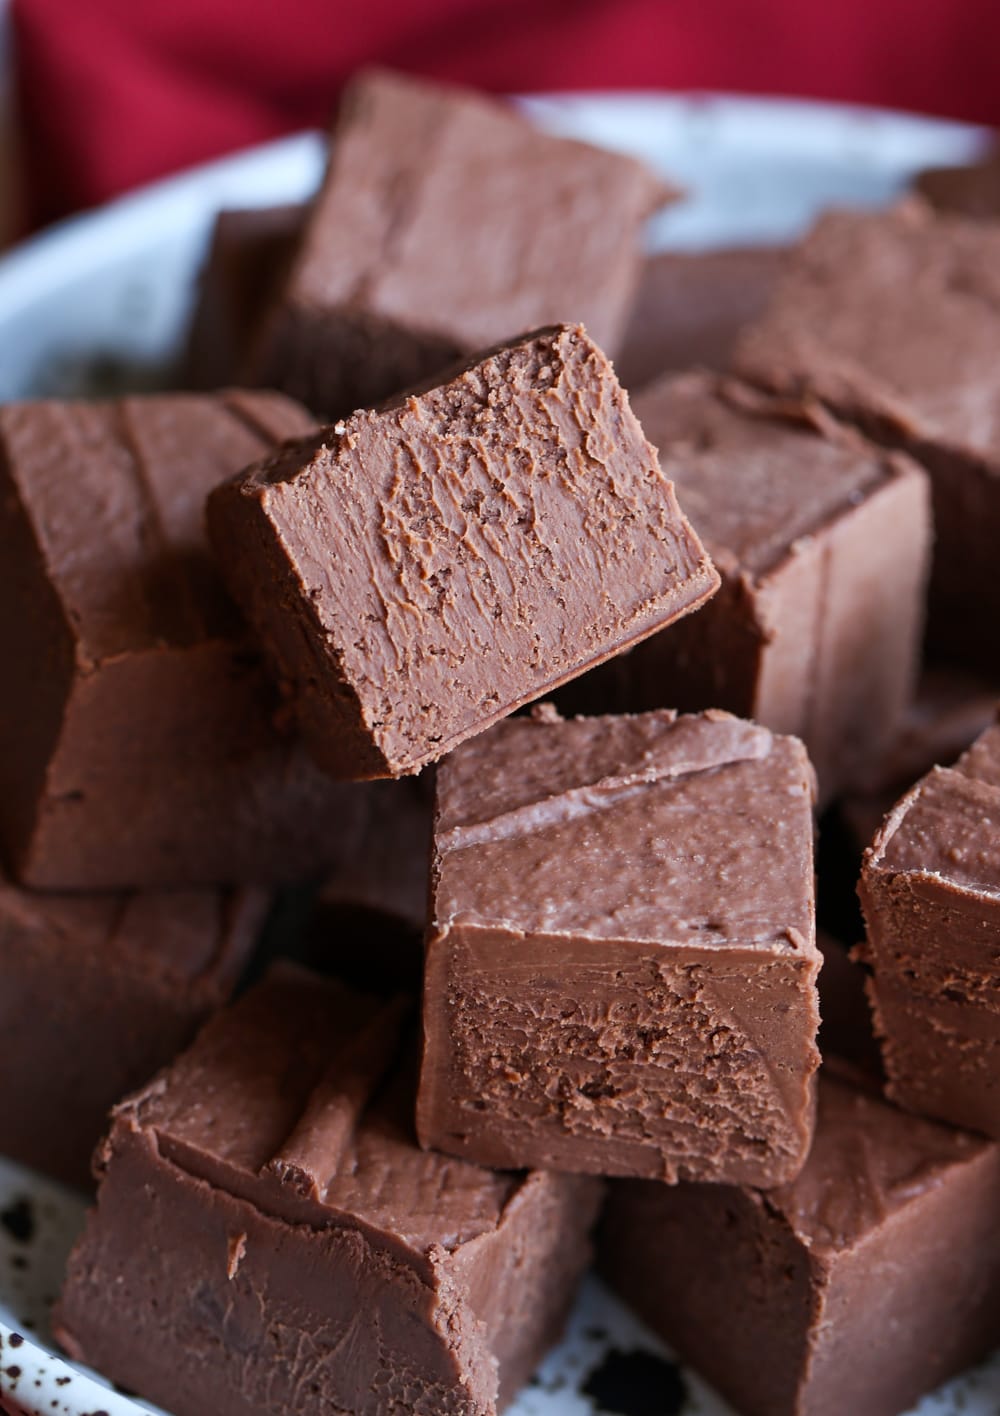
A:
564,374,931,800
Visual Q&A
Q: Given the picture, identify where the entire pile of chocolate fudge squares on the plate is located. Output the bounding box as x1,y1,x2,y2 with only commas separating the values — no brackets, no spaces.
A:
0,63,1000,1416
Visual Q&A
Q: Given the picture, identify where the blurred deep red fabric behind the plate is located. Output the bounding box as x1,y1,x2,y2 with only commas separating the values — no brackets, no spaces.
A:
13,0,1000,222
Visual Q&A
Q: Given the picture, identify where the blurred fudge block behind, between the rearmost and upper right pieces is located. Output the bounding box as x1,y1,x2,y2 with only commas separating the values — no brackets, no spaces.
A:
615,246,788,389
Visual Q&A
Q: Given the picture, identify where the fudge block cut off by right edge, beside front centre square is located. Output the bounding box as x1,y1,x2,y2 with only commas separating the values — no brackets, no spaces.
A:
858,725,1000,1137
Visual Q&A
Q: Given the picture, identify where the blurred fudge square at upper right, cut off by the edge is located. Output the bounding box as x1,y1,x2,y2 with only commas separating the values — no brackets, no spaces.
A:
734,201,1000,673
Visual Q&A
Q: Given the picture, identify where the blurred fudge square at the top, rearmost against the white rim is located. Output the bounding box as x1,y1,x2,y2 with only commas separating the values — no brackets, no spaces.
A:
251,72,669,418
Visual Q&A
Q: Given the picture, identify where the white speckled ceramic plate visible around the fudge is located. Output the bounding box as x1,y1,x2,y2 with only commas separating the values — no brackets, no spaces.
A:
0,95,1000,1416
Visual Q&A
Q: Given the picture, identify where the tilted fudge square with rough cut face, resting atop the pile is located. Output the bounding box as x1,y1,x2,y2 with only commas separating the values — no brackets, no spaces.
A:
208,326,718,777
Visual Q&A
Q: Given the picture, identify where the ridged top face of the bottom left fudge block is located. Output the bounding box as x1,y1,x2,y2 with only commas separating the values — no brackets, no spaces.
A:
116,964,521,1256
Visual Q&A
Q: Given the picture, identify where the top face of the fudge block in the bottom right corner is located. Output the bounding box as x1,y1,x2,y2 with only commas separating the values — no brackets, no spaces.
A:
765,1066,992,1257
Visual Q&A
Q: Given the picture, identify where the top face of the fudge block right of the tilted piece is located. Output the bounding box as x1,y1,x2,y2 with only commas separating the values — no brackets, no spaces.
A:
635,374,908,576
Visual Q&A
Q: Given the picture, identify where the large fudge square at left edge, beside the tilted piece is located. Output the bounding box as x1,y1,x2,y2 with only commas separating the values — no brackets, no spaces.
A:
0,392,365,889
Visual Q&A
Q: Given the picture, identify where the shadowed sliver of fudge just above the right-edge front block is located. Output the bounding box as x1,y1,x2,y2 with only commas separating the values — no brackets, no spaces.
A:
839,664,1000,854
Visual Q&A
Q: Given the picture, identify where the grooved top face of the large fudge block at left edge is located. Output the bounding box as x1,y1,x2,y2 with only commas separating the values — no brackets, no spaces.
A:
0,391,313,663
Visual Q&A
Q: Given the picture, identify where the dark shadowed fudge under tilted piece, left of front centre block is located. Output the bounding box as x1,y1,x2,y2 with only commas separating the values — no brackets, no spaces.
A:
309,773,433,993
